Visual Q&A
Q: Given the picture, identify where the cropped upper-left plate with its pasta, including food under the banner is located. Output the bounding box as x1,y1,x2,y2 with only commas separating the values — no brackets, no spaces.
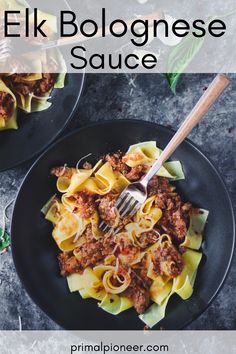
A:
0,1,84,171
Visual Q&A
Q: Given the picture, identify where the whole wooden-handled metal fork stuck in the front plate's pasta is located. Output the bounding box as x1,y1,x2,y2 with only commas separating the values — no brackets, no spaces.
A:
99,74,230,232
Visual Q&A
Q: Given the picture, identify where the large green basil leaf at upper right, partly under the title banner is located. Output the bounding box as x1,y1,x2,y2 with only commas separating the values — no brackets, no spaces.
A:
166,33,204,93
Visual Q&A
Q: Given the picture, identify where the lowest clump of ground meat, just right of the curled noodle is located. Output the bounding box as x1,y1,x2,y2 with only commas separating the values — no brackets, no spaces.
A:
124,270,150,314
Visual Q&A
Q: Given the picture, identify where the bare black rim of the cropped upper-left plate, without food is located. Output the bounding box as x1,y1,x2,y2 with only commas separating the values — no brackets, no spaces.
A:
0,74,84,171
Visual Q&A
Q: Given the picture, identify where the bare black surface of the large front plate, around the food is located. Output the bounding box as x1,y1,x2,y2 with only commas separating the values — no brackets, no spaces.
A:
11,120,235,329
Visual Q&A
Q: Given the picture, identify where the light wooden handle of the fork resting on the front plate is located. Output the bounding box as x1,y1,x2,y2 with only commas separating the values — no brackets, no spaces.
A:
157,74,230,165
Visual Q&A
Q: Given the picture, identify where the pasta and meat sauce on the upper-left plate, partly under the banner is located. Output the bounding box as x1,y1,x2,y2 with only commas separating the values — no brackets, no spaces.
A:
0,0,67,131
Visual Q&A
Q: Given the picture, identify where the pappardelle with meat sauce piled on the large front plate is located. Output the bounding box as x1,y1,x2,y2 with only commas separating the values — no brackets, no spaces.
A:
42,141,208,327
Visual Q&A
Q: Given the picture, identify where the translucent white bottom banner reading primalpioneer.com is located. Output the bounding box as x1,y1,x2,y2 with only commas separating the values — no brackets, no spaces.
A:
0,331,236,354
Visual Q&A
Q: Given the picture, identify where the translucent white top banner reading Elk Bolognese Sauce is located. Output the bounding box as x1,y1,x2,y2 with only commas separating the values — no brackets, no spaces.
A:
0,0,236,74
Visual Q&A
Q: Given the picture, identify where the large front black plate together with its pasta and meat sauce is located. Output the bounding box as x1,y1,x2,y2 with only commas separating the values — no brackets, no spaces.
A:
11,120,235,329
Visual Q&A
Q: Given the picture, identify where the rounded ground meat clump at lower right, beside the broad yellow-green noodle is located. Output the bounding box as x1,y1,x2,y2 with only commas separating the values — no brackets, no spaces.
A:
152,242,184,278
